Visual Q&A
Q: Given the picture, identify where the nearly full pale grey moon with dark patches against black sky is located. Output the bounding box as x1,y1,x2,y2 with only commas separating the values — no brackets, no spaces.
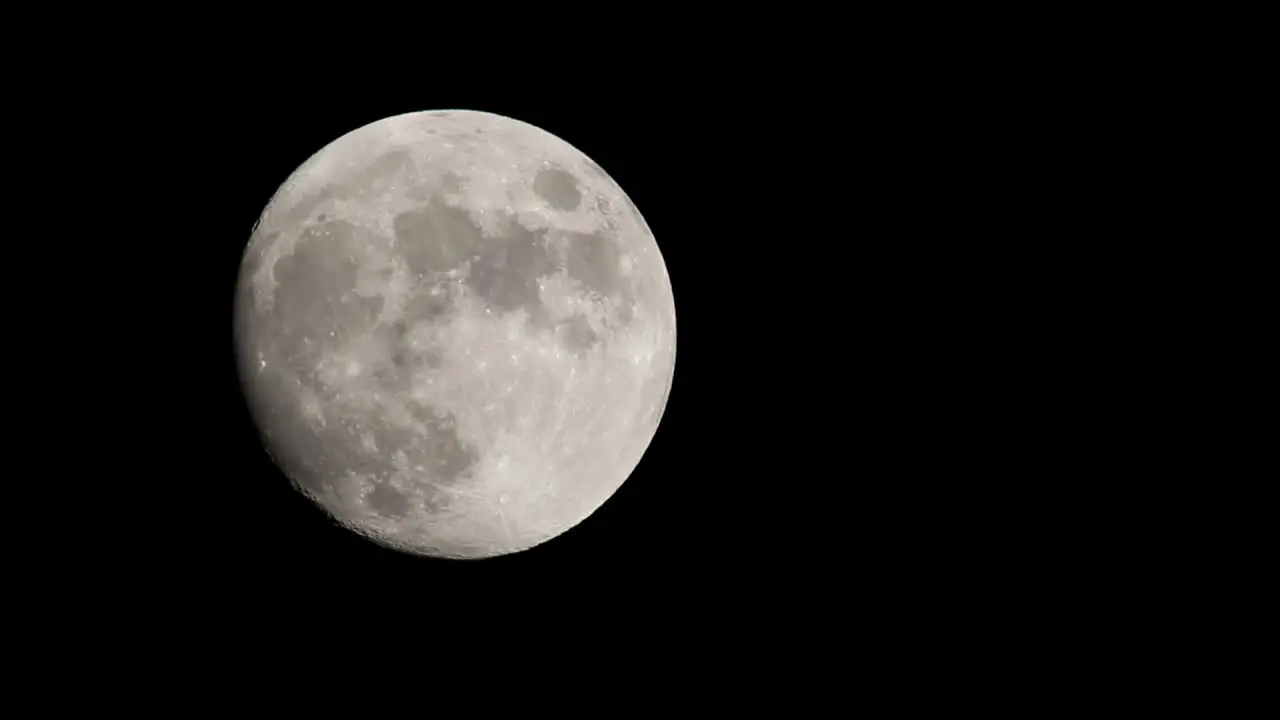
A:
236,110,676,557
